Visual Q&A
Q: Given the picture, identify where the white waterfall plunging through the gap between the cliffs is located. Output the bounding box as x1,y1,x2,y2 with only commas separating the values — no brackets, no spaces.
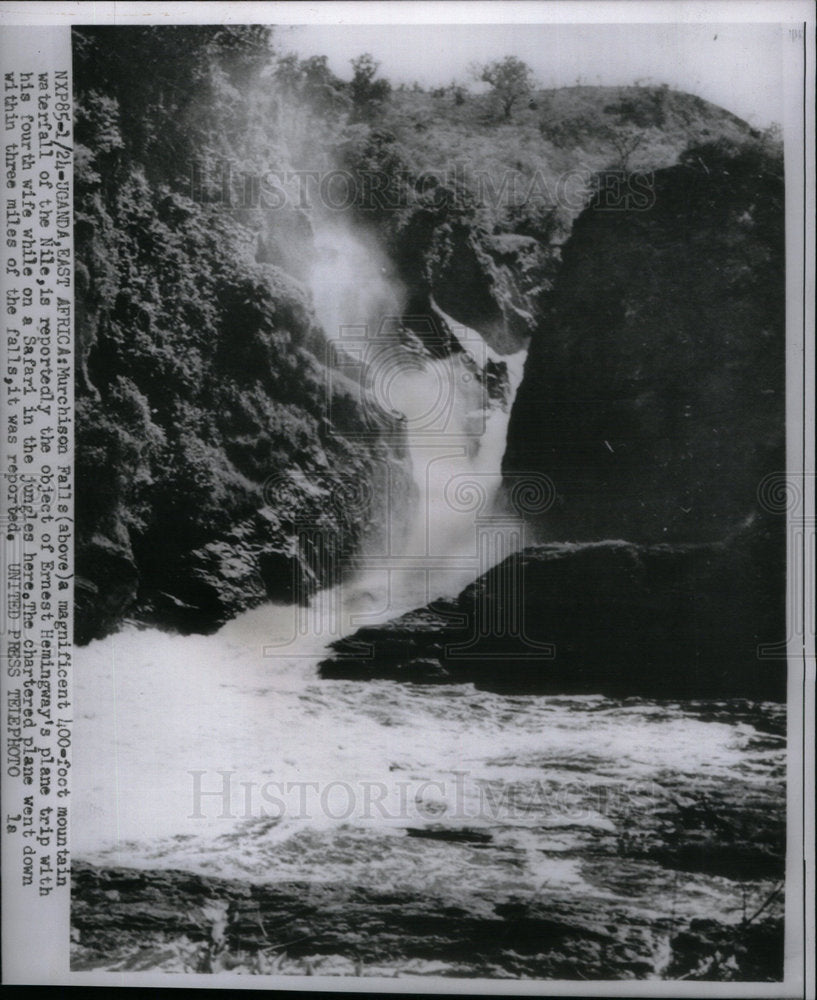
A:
310,225,525,632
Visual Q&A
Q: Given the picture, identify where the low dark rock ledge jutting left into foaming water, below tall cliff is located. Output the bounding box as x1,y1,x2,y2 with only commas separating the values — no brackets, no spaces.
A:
320,520,786,700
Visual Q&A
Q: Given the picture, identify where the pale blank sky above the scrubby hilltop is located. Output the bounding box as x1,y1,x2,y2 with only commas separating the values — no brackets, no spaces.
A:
276,23,787,127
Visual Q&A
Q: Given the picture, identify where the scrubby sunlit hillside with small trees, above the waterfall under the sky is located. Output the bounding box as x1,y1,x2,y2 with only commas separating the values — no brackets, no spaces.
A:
330,87,750,353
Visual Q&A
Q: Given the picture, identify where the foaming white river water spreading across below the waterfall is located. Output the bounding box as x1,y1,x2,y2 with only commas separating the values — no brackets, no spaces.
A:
73,620,783,915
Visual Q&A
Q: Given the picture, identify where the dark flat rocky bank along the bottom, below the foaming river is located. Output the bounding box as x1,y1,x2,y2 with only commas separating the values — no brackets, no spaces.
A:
71,860,783,981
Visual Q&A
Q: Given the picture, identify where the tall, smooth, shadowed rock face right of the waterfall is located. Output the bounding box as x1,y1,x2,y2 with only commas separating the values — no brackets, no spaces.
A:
504,145,785,542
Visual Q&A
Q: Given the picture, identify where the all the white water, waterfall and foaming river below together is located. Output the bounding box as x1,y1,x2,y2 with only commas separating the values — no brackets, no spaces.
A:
72,229,783,968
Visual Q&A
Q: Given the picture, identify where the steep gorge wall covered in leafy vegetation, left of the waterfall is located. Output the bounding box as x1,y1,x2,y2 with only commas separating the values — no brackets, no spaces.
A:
75,27,413,643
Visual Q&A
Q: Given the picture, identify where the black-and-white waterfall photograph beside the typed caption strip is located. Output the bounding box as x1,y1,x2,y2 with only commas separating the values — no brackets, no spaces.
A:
4,3,814,996
